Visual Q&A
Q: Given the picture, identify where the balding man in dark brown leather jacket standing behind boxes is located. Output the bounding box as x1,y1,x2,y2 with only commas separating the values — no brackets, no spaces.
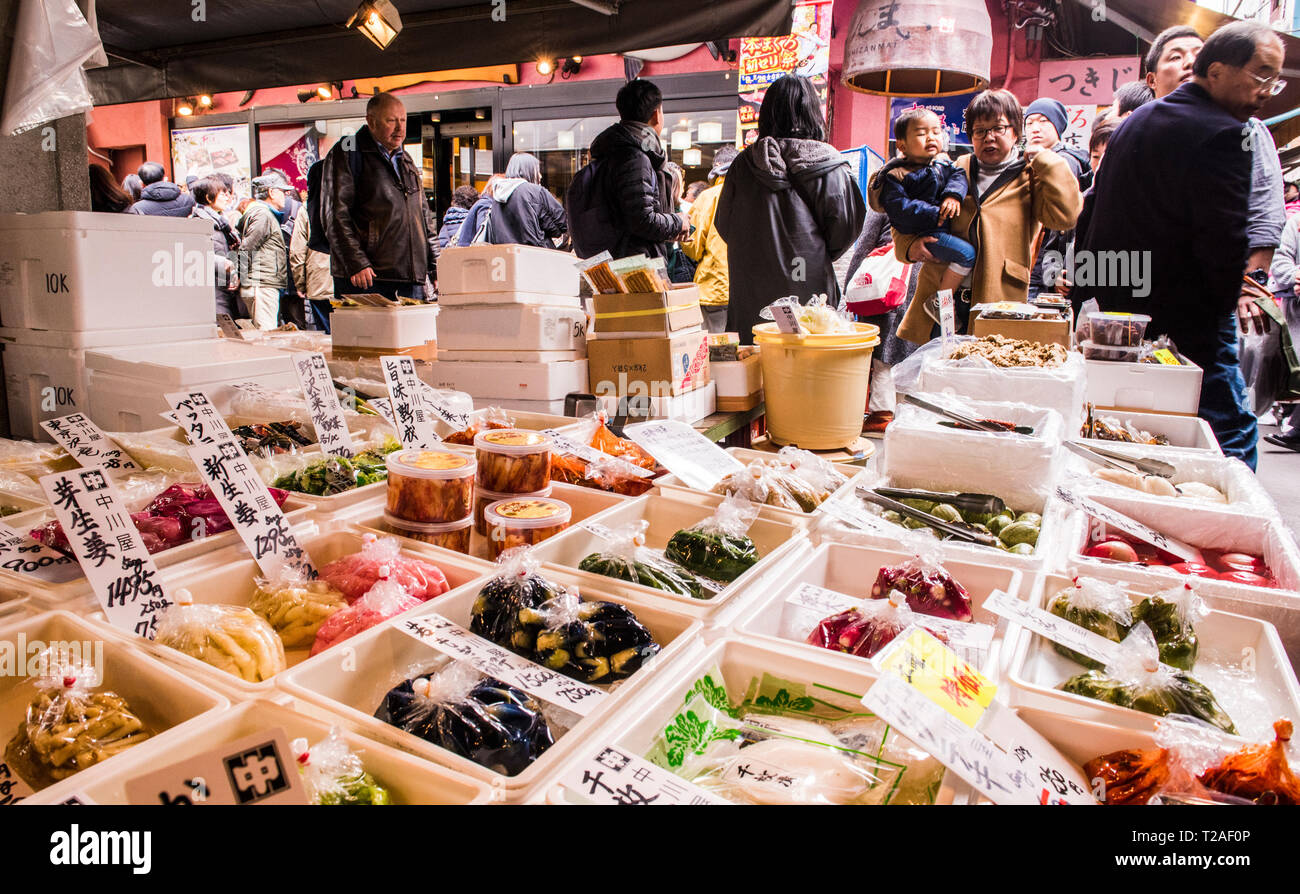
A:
321,94,438,298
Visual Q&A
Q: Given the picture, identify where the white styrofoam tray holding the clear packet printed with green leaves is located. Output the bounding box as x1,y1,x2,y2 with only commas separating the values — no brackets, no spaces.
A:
543,637,971,804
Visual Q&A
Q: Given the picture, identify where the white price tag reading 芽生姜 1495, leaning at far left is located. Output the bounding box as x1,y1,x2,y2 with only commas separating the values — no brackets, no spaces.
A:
40,469,172,639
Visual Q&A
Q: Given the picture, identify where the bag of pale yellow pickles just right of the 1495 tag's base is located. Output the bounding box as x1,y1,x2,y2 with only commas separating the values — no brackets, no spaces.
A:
153,589,287,683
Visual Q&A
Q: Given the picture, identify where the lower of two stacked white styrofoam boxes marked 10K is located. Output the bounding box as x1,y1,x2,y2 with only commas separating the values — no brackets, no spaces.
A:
0,324,216,441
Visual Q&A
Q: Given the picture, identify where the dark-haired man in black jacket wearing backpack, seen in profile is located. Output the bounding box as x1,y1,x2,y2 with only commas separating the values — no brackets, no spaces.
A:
566,78,690,257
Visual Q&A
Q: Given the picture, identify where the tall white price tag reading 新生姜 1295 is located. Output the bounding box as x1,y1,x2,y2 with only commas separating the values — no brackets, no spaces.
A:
189,441,316,578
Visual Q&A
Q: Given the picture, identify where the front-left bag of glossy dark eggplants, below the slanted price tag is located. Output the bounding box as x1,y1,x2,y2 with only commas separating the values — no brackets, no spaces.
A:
374,663,554,776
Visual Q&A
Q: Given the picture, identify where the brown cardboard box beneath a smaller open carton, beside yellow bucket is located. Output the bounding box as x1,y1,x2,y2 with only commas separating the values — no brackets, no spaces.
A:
586,329,710,396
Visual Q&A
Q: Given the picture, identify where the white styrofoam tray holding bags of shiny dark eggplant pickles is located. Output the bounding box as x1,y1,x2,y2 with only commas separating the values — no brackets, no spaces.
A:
280,568,699,802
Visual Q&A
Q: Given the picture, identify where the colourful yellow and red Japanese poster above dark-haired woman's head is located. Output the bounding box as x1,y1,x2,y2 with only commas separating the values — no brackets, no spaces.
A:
738,0,831,146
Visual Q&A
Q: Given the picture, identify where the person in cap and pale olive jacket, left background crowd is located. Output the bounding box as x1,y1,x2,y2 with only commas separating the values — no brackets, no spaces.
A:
239,175,289,329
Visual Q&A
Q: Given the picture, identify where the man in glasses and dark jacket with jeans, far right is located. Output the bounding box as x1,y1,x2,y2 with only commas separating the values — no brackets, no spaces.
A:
1071,22,1286,468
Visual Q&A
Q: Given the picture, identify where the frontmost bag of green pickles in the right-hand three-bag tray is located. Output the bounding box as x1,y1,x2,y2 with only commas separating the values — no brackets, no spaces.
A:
1061,622,1236,734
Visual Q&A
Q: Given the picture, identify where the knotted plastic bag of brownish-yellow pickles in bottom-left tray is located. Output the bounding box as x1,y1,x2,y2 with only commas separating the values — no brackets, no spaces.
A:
4,647,153,791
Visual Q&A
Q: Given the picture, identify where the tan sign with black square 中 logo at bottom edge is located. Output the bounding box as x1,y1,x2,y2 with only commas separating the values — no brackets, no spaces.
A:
126,726,309,807
